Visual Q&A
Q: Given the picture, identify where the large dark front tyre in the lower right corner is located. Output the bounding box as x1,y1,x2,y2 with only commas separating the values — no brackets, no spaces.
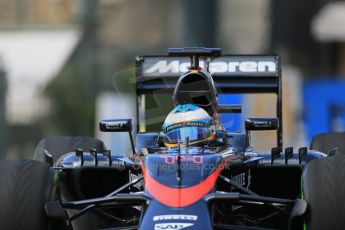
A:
302,154,345,230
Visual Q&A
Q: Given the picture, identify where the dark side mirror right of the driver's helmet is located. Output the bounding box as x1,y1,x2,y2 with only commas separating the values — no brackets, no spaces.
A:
245,118,279,131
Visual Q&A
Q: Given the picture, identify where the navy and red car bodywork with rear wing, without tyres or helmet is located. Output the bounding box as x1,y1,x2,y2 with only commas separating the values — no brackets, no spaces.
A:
46,49,325,230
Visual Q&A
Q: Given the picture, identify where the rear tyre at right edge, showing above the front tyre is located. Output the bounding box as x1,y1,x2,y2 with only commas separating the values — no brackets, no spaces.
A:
310,132,345,153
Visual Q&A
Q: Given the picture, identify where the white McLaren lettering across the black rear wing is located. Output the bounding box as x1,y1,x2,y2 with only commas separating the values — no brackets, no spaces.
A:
145,60,277,74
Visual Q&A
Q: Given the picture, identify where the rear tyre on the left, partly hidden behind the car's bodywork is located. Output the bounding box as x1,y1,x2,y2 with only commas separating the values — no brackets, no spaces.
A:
34,136,104,163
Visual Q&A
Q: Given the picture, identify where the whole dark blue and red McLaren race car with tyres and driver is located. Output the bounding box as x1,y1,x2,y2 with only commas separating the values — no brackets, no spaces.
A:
0,48,345,230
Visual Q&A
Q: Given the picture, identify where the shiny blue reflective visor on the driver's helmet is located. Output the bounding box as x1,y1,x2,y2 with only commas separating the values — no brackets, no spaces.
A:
164,126,211,144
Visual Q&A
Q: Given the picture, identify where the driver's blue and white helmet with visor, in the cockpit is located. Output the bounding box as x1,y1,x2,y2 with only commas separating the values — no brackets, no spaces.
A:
162,104,216,147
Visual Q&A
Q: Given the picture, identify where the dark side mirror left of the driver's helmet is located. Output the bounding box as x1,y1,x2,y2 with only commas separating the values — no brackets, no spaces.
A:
99,119,132,132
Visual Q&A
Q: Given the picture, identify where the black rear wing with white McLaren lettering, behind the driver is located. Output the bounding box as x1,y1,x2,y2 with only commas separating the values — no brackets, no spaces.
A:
136,55,282,147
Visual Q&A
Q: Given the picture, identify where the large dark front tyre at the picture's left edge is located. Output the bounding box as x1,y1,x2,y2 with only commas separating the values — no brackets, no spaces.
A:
0,160,52,230
